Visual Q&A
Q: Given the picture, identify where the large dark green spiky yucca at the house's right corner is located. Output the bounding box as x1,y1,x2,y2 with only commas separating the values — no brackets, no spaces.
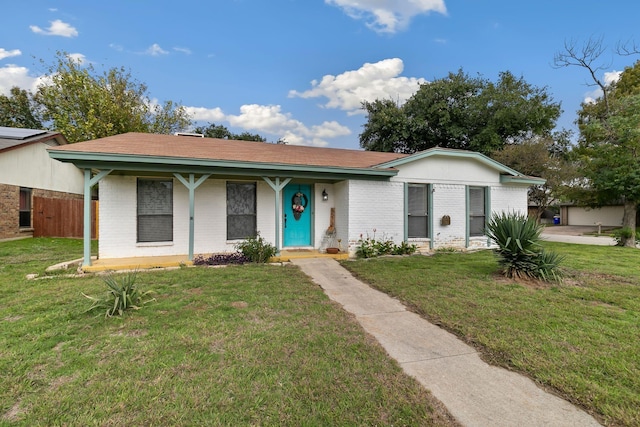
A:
487,212,563,281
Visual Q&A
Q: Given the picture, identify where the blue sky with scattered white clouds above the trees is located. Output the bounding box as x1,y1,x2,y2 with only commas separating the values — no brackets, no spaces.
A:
0,0,640,149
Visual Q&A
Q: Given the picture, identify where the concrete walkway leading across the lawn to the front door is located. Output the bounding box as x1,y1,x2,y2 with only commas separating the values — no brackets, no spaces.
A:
292,258,599,427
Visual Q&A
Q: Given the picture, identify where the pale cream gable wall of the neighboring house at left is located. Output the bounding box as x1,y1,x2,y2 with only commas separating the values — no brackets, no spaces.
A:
0,143,84,194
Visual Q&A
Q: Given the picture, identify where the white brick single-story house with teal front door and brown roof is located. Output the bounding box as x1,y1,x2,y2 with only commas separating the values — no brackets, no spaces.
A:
49,133,544,265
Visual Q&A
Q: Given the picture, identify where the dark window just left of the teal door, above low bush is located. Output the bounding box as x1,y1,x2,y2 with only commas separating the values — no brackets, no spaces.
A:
227,182,257,240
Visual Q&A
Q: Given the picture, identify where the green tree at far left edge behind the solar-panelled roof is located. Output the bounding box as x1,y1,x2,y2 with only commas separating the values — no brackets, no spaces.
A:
0,86,43,129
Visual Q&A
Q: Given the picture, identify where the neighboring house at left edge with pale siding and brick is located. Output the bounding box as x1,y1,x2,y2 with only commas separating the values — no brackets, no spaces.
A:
0,127,84,239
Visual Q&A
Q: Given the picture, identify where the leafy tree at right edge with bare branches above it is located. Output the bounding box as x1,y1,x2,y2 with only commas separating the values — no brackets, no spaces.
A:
555,39,640,247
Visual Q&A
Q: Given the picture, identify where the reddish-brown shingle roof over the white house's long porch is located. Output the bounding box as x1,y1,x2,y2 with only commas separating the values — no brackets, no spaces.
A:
47,133,407,168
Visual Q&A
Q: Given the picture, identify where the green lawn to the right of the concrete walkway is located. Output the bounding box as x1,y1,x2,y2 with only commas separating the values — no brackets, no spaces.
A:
344,243,640,425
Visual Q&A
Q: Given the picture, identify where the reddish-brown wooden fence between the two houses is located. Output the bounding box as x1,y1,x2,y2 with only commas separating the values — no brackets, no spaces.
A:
33,197,98,239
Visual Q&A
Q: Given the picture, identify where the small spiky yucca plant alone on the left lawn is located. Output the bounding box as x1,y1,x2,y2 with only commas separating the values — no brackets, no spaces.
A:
82,271,155,317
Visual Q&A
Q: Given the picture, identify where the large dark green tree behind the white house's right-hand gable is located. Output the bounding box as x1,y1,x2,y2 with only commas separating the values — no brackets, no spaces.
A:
360,70,561,155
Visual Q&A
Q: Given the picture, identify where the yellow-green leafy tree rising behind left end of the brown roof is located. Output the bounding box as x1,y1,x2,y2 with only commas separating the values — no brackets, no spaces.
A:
35,52,191,142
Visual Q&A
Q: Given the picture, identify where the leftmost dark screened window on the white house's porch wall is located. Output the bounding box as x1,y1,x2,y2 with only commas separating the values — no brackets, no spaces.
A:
138,179,173,242
